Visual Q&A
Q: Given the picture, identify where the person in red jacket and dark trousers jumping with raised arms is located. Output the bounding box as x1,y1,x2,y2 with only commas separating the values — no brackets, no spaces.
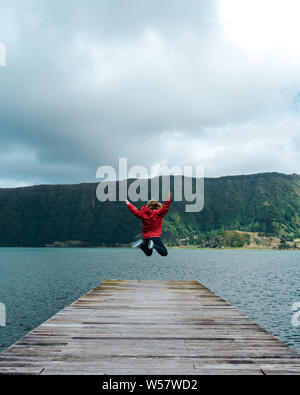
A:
125,193,171,256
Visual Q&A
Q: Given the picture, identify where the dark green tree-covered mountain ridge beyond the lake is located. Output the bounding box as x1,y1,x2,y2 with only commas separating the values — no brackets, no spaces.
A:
0,173,300,247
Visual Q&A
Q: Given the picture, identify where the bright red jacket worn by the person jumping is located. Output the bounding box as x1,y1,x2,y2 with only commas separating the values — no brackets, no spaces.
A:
128,199,171,239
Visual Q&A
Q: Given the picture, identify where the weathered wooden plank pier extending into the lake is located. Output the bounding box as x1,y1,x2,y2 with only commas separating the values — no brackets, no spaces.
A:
0,280,300,375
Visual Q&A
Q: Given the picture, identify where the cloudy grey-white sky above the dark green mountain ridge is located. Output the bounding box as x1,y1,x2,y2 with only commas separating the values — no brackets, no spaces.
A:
0,0,300,187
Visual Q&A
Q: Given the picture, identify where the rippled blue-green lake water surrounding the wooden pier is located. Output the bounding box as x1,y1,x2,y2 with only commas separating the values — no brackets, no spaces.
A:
0,248,300,352
